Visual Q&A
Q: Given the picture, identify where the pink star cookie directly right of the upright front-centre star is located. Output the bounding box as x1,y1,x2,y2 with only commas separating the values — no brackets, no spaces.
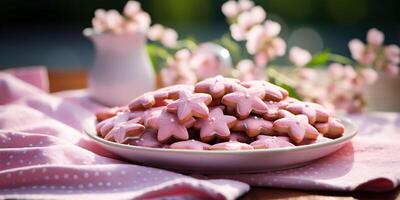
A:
232,116,273,137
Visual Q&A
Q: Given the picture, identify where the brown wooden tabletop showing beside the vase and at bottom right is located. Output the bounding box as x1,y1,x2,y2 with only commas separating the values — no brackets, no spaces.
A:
49,71,400,200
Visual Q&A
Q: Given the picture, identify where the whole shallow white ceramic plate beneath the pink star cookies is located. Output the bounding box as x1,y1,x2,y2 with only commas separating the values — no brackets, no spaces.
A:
84,119,357,174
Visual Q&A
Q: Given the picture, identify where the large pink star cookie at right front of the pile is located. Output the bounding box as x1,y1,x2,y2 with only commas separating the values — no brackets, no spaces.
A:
273,115,319,144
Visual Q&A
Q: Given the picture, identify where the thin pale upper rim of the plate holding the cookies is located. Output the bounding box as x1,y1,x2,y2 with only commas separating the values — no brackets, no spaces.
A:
83,117,358,155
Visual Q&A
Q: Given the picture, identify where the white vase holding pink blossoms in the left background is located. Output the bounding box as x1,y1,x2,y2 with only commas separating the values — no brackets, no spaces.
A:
84,29,155,106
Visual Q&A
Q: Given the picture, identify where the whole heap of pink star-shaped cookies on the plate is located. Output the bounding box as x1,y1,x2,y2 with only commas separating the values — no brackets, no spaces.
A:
96,76,344,150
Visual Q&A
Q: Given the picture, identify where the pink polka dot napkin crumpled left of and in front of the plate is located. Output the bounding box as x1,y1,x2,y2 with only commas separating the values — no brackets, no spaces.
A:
0,72,249,199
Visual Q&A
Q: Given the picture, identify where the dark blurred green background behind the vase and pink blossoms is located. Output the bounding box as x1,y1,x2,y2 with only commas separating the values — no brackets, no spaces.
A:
0,0,400,70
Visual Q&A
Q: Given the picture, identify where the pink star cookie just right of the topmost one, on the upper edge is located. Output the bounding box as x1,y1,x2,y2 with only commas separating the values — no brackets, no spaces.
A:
241,80,289,101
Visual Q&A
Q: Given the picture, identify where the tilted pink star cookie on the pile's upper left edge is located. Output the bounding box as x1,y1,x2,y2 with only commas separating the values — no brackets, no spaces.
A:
128,91,168,111
